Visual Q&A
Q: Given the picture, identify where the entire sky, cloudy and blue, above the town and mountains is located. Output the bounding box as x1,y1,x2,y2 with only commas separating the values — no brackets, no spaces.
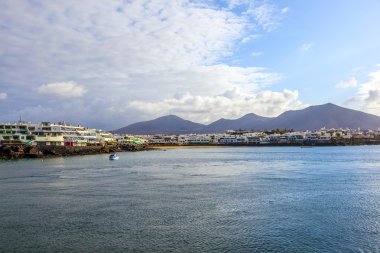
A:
0,0,380,130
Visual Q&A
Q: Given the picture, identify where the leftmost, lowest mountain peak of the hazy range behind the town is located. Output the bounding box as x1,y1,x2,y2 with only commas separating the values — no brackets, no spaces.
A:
112,115,205,134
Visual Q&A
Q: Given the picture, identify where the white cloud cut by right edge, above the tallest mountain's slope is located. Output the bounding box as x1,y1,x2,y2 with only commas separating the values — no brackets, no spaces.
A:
346,70,380,115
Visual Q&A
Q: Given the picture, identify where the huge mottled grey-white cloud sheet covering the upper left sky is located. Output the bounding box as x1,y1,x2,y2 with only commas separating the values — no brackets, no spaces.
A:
0,0,290,126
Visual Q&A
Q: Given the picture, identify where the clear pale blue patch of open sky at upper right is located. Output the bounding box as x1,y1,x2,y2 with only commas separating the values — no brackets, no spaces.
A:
229,1,380,105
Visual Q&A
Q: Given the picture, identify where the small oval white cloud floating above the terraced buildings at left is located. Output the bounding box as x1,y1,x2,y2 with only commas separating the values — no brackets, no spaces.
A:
38,81,86,97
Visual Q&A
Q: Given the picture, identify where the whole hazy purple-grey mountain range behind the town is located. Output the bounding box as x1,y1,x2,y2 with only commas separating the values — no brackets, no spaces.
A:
112,103,380,134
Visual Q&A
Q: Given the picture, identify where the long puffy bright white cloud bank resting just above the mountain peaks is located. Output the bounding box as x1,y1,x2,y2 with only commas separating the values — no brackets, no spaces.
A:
130,88,307,123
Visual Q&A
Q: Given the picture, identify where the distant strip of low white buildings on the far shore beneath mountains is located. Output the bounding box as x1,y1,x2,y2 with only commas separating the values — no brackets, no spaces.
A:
140,129,380,146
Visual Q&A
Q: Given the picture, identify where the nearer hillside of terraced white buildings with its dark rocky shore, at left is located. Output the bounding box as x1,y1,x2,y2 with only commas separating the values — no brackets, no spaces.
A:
0,120,148,159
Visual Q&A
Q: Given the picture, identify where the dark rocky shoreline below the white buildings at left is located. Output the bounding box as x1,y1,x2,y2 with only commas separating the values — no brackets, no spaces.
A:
0,144,150,160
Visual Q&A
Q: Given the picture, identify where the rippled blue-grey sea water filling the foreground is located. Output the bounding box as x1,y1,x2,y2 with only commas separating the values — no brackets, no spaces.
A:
0,146,380,252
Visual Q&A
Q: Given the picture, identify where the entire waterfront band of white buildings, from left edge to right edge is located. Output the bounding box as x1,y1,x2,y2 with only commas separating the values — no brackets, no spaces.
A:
0,121,380,147
